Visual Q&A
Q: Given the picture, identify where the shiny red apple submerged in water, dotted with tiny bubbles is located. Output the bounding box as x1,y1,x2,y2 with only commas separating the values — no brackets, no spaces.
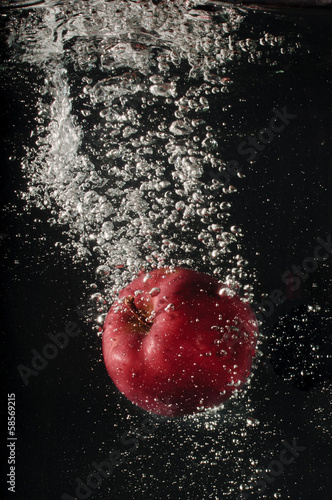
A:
103,267,258,417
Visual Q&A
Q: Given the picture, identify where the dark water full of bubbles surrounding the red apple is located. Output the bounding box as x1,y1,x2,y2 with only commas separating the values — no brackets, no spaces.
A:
0,1,332,500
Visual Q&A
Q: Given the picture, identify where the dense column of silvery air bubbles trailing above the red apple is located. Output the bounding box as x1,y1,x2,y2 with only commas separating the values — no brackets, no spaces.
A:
11,1,272,313
